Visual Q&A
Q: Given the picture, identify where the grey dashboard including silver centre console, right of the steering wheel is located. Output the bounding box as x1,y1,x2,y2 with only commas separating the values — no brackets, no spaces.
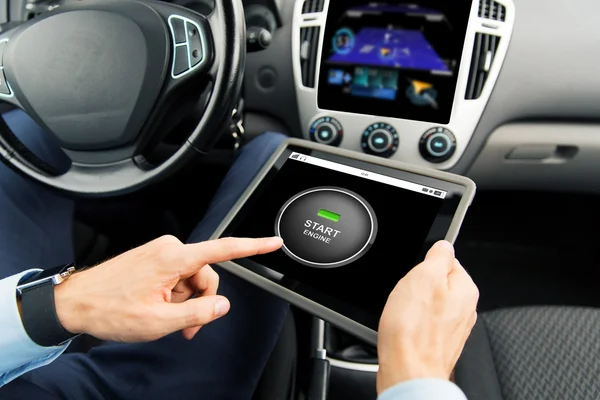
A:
244,0,600,192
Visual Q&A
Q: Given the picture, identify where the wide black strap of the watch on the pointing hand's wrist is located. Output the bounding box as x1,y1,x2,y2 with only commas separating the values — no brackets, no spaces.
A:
21,281,76,347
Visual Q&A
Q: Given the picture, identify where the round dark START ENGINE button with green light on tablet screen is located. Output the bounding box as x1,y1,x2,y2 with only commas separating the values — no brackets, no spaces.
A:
275,187,377,269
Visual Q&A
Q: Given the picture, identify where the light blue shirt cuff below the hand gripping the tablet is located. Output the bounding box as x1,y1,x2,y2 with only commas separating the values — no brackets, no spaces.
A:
377,379,467,400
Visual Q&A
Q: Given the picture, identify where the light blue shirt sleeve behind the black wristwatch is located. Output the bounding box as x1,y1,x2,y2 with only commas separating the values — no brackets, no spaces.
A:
0,269,69,387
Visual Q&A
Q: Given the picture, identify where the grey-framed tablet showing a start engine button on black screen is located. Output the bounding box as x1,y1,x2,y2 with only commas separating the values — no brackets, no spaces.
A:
213,139,475,344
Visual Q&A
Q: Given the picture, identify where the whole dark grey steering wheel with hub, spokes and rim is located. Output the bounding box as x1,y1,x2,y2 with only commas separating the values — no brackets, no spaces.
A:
0,0,246,197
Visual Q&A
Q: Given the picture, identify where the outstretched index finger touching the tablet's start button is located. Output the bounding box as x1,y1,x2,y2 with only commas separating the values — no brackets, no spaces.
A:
184,237,283,272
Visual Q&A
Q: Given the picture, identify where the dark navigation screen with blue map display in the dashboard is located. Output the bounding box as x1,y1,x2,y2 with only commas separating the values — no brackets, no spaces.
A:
318,0,471,124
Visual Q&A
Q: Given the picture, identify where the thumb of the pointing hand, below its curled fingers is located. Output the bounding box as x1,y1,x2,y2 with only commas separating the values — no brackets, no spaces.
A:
166,296,230,332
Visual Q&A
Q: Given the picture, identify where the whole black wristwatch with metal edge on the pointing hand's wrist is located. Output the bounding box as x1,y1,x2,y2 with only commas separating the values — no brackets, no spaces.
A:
17,264,77,347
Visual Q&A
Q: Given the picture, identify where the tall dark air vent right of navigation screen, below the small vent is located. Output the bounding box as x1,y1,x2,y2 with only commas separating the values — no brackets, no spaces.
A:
465,33,500,100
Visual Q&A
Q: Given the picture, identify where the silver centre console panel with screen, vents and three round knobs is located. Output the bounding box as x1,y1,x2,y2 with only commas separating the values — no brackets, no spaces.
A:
292,0,515,169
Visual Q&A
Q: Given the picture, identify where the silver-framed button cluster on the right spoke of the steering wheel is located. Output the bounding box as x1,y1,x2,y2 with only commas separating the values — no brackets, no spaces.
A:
169,15,206,79
